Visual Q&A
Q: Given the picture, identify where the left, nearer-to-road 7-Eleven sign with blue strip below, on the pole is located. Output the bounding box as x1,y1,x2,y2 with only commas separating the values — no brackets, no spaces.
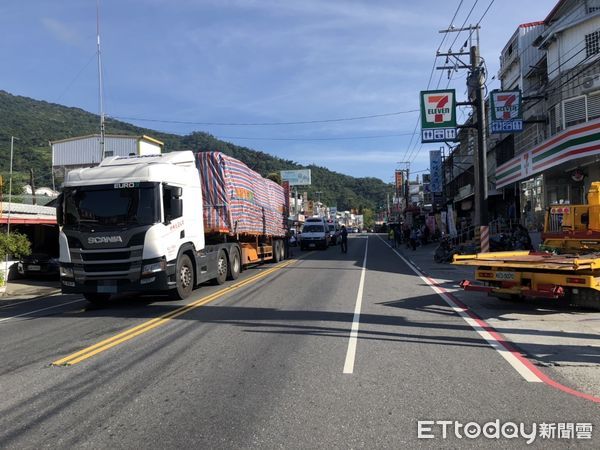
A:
421,89,456,143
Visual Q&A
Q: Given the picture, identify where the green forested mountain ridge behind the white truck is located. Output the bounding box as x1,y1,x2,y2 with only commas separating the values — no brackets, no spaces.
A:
0,90,392,214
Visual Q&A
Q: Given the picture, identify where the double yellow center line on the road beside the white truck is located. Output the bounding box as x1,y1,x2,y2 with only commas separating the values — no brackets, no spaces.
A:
52,260,295,366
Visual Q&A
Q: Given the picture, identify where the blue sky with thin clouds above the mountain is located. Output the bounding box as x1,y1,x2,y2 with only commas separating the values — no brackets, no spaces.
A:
0,0,557,182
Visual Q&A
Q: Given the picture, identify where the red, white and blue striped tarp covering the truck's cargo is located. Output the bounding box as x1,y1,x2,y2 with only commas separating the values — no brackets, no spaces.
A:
198,152,285,236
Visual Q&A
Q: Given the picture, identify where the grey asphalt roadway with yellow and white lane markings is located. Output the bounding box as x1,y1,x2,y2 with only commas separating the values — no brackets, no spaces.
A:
0,235,600,448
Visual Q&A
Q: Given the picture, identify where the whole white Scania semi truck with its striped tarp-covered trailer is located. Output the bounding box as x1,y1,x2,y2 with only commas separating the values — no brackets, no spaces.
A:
57,151,285,303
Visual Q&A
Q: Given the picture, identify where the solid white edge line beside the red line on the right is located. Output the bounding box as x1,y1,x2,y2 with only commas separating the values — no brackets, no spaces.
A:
378,236,543,383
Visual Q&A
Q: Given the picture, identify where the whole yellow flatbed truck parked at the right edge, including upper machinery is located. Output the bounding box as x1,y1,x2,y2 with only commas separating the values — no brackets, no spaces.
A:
453,182,600,310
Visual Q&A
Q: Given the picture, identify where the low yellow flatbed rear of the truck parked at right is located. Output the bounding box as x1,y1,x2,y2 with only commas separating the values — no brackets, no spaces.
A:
454,251,600,310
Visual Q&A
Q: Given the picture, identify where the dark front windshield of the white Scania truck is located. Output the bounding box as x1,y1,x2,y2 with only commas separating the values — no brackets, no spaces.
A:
64,183,158,227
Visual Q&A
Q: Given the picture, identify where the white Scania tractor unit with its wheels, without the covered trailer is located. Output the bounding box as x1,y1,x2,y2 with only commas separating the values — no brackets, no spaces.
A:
57,151,234,303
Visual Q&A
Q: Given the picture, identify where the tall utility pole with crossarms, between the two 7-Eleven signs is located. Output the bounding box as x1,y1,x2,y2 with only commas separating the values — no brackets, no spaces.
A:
436,25,488,226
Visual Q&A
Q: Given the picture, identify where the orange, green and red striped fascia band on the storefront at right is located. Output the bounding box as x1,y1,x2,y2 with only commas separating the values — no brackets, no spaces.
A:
496,119,600,188
